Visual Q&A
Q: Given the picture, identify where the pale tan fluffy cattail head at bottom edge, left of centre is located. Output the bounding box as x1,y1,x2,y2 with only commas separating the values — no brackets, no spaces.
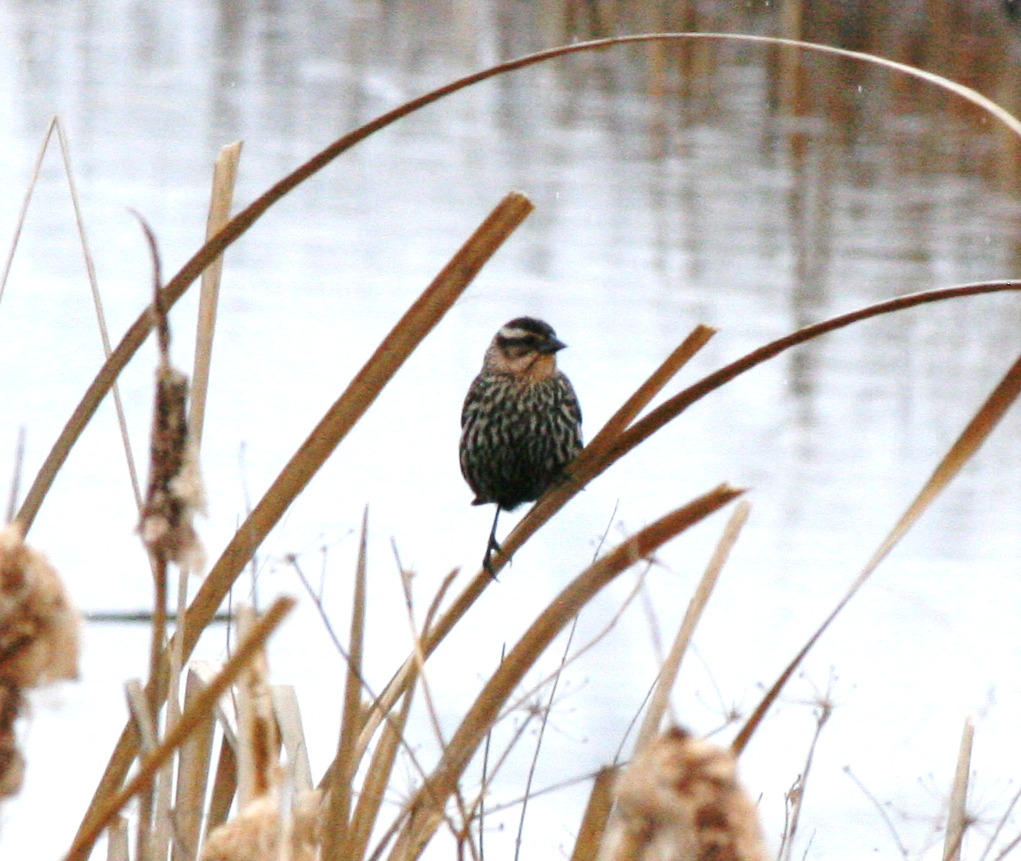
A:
199,790,323,861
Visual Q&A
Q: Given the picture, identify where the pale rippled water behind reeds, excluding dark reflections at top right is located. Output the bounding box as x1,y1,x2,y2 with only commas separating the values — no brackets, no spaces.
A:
0,2,1021,858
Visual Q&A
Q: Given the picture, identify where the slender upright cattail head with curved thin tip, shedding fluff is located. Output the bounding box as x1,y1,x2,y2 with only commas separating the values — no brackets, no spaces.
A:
139,218,205,572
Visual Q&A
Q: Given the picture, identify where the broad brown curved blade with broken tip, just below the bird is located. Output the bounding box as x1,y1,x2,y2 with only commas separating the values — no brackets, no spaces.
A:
390,485,742,861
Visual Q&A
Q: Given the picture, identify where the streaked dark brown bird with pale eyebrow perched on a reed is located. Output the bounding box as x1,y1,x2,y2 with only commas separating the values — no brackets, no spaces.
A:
460,317,582,573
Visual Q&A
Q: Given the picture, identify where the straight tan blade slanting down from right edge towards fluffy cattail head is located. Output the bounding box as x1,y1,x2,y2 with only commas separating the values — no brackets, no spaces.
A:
733,349,1021,754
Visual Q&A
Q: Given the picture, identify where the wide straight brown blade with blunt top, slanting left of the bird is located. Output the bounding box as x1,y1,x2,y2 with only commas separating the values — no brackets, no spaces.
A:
71,193,533,849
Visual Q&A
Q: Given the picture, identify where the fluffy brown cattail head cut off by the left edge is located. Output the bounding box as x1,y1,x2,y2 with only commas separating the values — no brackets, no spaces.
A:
0,522,81,798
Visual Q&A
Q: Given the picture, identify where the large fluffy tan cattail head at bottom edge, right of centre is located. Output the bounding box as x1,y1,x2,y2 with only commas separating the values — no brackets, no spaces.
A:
601,728,767,861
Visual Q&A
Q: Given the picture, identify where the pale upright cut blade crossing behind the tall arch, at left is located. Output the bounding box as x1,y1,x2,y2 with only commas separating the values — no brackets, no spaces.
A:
188,141,241,447
